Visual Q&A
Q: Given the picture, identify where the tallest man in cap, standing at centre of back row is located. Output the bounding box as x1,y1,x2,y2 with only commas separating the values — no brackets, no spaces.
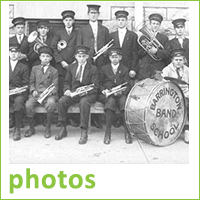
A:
77,4,109,128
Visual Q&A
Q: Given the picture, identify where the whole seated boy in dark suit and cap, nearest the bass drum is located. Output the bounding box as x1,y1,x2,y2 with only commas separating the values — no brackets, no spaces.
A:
99,47,132,144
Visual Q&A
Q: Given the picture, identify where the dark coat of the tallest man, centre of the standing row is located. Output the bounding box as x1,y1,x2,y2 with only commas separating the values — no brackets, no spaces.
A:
77,24,109,68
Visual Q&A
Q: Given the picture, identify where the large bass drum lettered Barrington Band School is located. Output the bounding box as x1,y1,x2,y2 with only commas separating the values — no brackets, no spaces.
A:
125,79,186,146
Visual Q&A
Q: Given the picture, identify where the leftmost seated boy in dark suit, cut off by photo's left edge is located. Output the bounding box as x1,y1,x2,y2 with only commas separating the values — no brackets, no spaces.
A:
9,43,29,141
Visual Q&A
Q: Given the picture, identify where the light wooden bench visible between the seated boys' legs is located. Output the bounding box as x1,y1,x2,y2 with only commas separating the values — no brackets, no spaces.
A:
35,102,104,133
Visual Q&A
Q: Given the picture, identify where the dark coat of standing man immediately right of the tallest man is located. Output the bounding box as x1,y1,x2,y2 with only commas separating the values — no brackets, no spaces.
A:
110,30,138,72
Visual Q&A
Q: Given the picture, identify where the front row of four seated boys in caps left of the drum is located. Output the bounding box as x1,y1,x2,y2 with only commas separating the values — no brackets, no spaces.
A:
9,44,189,144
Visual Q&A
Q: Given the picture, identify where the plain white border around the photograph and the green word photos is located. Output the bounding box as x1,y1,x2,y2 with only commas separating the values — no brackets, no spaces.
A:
1,2,199,199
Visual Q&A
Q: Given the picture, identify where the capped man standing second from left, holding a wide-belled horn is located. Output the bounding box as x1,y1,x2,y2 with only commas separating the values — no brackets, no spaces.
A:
29,19,54,67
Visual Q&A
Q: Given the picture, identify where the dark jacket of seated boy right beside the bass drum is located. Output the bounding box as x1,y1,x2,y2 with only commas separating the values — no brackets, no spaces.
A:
99,64,130,95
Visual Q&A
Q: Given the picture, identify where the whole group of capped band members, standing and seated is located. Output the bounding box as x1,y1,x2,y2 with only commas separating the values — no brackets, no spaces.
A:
9,5,189,144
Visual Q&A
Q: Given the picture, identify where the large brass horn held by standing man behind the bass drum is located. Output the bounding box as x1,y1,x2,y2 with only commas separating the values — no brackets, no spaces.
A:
138,26,164,61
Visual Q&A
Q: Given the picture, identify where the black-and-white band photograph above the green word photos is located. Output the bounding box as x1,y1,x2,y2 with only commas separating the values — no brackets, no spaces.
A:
2,1,199,198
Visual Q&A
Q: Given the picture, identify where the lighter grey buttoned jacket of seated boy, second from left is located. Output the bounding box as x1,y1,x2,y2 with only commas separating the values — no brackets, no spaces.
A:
29,65,58,96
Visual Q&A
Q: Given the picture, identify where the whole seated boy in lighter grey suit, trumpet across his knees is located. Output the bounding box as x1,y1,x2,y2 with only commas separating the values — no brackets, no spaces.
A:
25,46,58,138
